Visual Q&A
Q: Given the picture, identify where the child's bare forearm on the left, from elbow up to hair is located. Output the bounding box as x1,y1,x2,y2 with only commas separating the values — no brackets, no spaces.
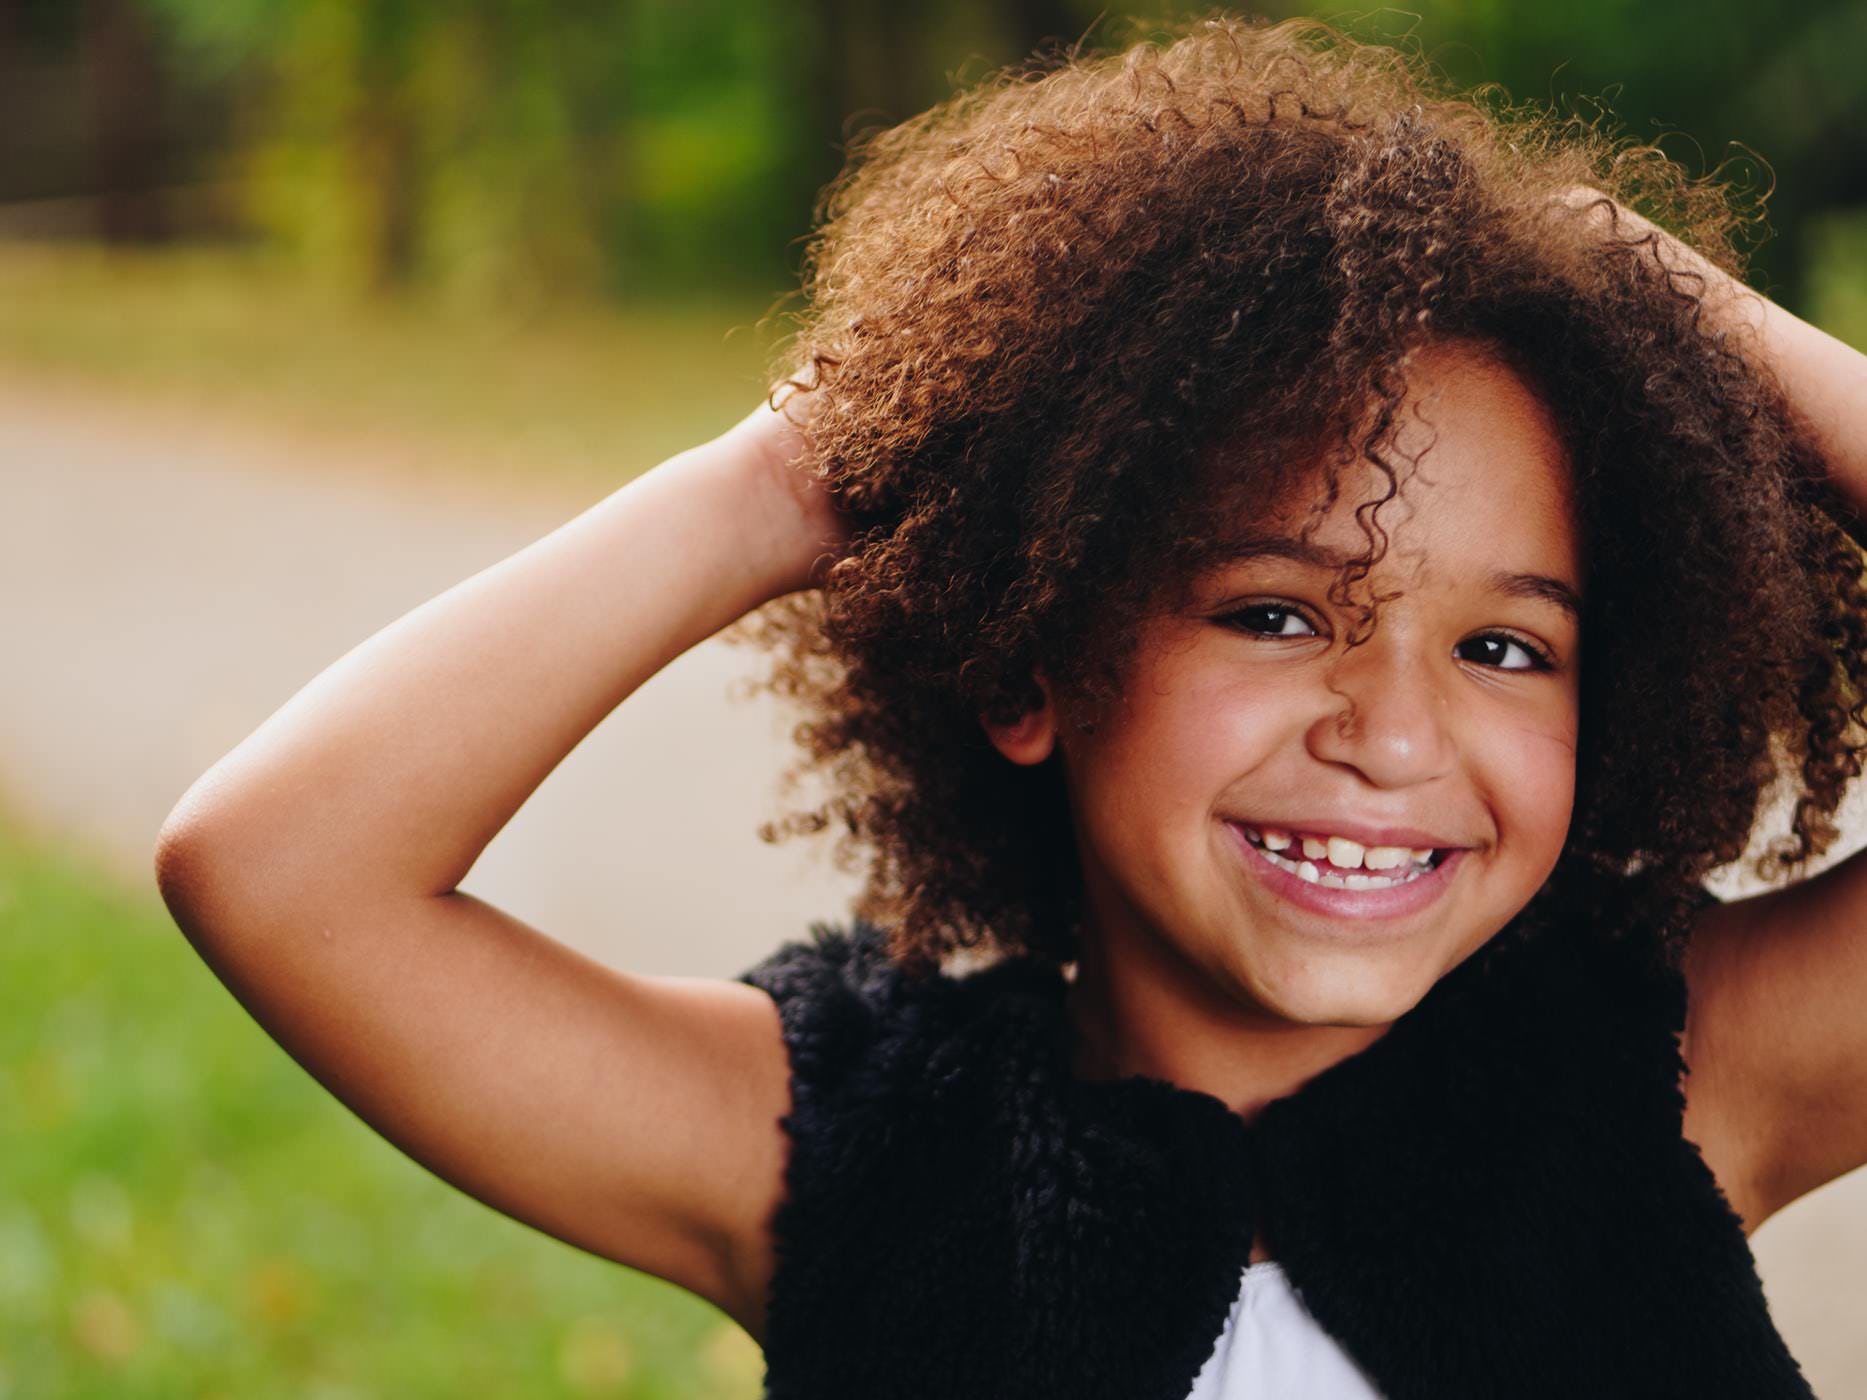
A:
162,392,833,898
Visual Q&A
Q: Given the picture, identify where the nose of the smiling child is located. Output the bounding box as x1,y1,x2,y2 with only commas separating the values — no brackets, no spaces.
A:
1309,623,1456,788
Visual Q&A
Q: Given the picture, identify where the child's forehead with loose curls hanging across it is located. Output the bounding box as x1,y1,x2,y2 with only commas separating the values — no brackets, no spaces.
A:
1225,342,1581,601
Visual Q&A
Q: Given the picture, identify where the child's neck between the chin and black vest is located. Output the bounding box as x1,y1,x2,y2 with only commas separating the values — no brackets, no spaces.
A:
1064,933,1389,1122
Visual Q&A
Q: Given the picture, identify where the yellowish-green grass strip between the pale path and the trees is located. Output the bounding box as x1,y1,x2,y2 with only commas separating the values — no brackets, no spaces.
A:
0,245,786,483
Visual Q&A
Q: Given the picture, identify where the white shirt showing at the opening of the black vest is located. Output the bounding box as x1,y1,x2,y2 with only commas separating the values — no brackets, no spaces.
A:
1187,1260,1382,1400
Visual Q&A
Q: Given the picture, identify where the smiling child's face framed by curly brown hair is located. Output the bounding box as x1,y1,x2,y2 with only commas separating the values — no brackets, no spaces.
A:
991,334,1583,1025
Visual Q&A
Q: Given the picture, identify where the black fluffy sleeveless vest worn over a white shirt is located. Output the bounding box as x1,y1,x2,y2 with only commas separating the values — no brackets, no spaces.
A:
739,920,1811,1400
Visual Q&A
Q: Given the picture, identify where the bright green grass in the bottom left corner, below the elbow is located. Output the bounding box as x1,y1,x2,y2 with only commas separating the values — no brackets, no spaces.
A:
0,819,762,1400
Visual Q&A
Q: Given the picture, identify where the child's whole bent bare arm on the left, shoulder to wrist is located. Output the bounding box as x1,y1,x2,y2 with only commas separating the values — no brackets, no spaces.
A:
157,405,844,1337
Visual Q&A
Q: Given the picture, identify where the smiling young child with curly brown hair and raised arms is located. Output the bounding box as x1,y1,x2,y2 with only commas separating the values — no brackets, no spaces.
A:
157,19,1867,1400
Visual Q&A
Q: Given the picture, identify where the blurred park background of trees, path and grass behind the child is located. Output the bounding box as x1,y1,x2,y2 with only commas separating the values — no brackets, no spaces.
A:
0,0,1867,1400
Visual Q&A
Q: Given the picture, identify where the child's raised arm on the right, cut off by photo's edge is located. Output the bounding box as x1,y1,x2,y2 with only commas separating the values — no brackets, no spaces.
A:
1570,190,1867,1228
